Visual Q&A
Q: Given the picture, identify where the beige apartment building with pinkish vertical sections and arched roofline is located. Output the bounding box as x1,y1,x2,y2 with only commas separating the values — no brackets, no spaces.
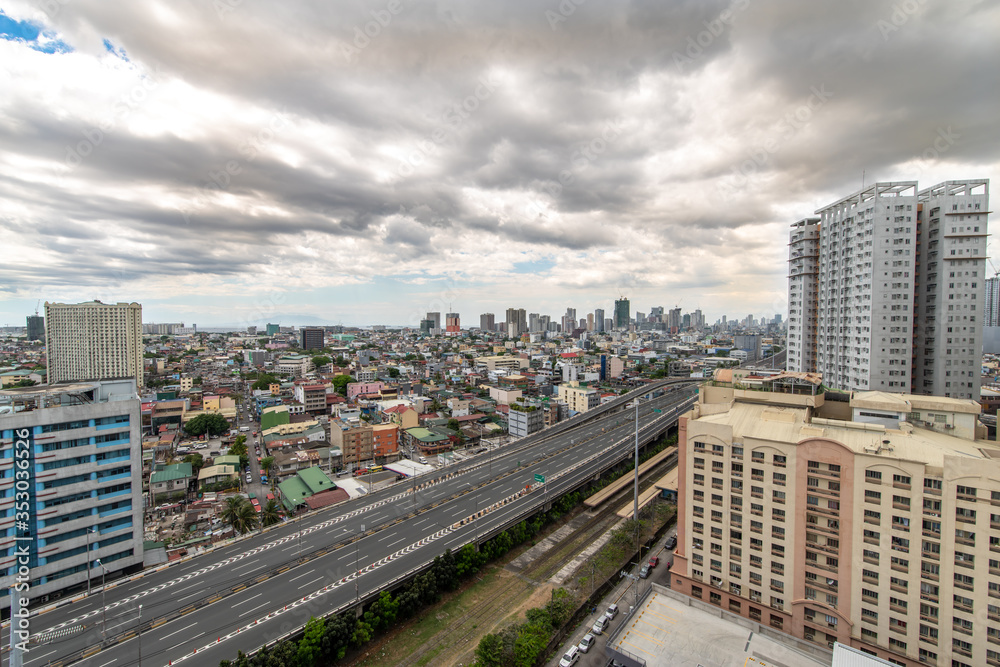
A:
671,369,1000,667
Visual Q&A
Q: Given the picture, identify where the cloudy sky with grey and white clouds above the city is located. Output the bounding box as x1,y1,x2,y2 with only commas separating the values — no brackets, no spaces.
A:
0,0,1000,327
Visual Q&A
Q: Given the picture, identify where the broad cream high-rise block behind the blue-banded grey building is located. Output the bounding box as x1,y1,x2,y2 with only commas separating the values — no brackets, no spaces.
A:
45,301,144,387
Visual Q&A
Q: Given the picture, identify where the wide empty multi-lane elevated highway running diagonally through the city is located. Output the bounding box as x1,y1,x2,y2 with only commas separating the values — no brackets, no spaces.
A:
15,380,695,667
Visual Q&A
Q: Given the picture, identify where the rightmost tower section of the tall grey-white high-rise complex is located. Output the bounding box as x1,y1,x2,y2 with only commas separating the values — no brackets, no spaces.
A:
913,179,989,401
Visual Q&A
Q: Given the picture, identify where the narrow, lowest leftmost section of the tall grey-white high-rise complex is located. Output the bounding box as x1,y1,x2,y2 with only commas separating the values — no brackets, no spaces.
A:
788,218,819,372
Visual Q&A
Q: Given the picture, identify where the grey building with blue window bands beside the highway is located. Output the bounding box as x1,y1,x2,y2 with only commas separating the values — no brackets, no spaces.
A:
0,378,143,606
